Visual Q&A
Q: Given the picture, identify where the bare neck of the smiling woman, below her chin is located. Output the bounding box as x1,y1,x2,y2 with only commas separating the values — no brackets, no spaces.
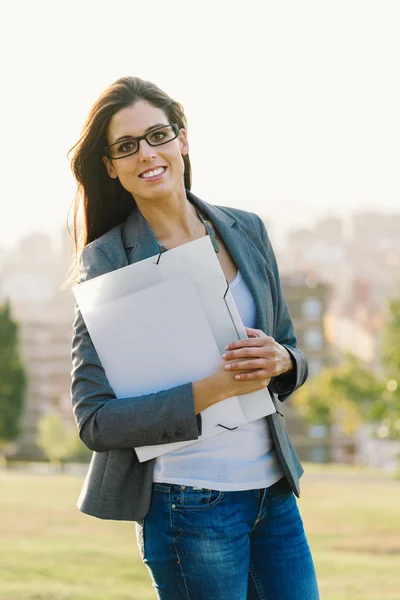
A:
135,187,204,243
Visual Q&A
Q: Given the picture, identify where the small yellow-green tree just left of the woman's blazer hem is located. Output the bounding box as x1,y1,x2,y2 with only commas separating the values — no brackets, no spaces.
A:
37,414,91,469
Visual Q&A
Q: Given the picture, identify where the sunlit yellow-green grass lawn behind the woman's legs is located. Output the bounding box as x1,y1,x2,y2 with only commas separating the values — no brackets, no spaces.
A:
0,469,400,600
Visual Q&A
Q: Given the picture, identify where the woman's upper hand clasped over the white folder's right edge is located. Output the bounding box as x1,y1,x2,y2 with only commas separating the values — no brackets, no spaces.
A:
222,327,293,381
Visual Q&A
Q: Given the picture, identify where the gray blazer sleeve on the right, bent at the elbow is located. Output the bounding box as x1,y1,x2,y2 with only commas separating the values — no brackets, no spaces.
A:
256,215,308,402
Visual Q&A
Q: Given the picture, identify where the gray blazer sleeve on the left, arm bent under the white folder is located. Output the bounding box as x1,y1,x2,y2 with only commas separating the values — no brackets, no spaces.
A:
71,246,201,452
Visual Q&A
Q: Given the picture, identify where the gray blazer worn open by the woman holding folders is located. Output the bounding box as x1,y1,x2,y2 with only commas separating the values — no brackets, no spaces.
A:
71,192,308,521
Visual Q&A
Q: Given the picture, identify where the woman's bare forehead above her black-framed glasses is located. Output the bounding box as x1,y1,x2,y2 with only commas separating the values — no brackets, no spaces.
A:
107,100,168,143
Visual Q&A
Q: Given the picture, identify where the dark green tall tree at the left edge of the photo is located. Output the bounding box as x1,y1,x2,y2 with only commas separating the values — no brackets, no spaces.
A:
0,302,26,453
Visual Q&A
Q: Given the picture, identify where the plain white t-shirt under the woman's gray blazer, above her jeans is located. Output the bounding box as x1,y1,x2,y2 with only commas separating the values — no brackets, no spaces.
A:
153,271,283,491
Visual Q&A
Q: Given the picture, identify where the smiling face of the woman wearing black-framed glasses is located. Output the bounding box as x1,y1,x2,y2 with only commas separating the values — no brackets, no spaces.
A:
103,100,189,202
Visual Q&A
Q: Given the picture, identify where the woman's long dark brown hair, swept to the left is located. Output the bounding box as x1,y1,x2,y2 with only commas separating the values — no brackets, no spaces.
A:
67,77,192,284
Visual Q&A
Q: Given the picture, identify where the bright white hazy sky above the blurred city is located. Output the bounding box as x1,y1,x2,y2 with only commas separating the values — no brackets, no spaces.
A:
0,0,400,247
